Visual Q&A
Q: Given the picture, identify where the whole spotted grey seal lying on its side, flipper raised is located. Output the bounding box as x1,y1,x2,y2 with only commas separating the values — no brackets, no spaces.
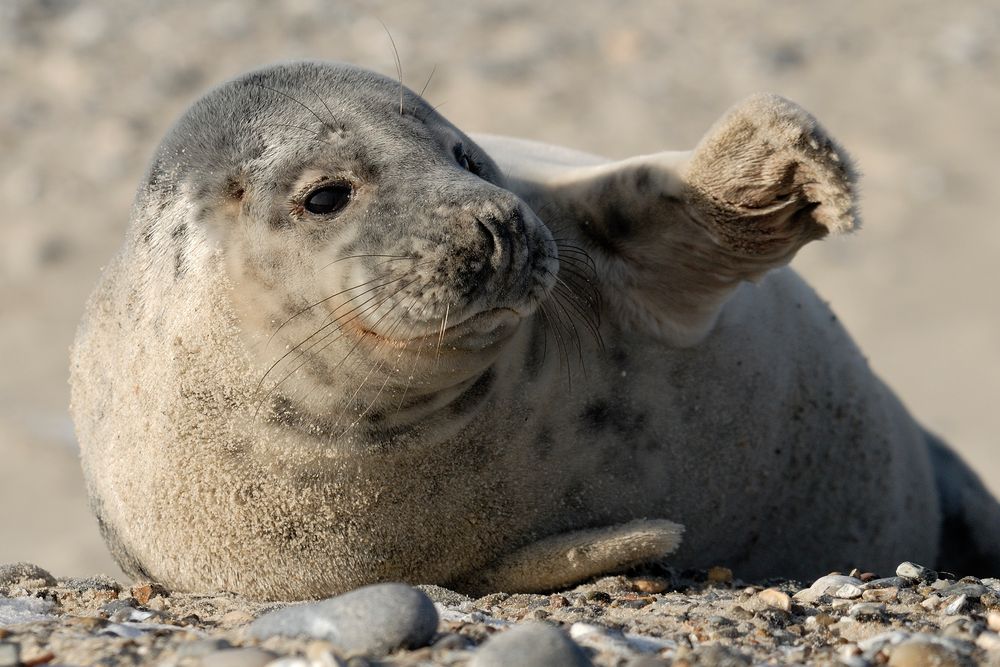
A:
71,62,1000,599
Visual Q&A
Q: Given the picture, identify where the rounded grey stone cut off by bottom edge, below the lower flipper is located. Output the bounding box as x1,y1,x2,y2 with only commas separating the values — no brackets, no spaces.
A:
469,623,592,667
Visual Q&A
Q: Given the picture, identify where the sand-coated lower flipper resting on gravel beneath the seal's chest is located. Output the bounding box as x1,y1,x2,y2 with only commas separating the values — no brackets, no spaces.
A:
449,519,684,595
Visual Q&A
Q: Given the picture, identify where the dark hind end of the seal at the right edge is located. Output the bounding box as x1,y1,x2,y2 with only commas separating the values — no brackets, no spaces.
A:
926,433,1000,577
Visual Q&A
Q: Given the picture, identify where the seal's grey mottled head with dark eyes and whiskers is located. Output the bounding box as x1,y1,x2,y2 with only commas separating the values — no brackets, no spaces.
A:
136,62,558,426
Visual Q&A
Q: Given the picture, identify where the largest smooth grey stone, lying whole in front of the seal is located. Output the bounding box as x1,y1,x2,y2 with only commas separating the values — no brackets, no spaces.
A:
250,584,438,656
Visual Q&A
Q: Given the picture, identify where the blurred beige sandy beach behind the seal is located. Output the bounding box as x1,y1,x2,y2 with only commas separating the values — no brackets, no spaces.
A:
0,0,1000,575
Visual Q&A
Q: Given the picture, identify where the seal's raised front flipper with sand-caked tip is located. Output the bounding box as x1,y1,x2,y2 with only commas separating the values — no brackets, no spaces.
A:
477,95,857,345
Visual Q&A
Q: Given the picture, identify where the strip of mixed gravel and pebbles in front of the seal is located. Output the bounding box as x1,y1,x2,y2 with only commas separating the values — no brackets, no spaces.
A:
0,569,1000,667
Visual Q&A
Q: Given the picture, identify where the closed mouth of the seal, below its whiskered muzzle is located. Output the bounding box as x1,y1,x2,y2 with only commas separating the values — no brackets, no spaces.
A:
360,308,525,350
